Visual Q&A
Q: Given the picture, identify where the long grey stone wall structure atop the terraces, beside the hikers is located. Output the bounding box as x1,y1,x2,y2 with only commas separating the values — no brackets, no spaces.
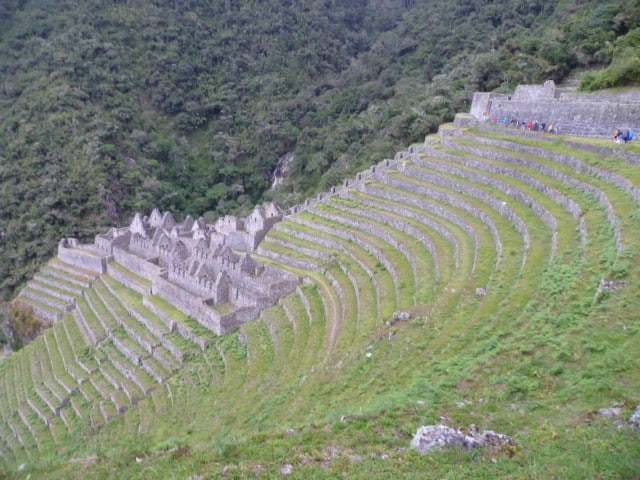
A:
470,80,640,137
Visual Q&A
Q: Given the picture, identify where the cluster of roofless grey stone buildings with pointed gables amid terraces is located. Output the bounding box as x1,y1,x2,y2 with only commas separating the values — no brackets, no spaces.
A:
52,203,300,334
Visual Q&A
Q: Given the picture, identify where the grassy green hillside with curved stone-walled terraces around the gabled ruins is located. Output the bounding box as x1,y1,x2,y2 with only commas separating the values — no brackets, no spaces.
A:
0,127,640,478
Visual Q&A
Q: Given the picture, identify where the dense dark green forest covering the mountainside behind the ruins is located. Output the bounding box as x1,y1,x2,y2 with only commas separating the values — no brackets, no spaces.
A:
0,0,640,340
